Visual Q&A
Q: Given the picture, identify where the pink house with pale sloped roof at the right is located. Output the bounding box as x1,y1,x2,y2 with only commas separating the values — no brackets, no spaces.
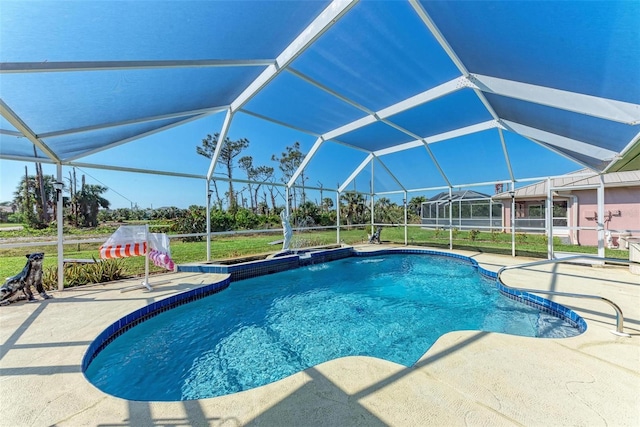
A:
493,170,640,247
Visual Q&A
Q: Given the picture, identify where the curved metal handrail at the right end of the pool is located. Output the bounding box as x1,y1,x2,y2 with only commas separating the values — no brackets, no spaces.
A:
496,255,637,338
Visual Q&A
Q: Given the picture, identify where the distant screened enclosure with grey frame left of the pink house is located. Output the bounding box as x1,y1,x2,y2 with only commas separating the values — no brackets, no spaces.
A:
421,190,502,230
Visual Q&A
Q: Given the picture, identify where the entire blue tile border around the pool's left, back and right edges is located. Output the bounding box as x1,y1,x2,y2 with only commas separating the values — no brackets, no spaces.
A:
82,247,587,372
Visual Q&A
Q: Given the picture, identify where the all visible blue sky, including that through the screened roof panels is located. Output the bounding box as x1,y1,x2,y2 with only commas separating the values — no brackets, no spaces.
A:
0,1,624,208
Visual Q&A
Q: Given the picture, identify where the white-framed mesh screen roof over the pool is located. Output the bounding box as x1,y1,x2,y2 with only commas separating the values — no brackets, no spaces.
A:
0,0,640,194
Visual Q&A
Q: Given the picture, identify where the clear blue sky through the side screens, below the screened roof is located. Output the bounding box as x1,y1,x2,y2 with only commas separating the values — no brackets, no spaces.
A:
0,109,580,208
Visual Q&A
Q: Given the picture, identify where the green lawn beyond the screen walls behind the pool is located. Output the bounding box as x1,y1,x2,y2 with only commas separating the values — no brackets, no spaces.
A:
0,226,629,279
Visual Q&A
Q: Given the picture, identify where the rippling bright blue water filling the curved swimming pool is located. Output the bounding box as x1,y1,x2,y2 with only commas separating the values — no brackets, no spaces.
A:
85,255,579,401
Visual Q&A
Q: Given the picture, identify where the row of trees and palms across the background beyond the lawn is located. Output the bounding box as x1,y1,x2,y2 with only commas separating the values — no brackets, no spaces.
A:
8,133,426,234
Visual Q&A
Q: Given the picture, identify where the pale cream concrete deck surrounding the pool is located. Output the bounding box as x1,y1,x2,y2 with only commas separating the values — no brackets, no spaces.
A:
0,246,640,426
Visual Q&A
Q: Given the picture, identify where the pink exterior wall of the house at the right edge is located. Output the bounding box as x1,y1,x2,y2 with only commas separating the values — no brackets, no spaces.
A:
573,187,640,246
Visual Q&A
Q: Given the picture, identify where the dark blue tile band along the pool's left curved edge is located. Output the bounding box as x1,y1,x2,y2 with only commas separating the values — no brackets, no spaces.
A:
82,277,231,372
